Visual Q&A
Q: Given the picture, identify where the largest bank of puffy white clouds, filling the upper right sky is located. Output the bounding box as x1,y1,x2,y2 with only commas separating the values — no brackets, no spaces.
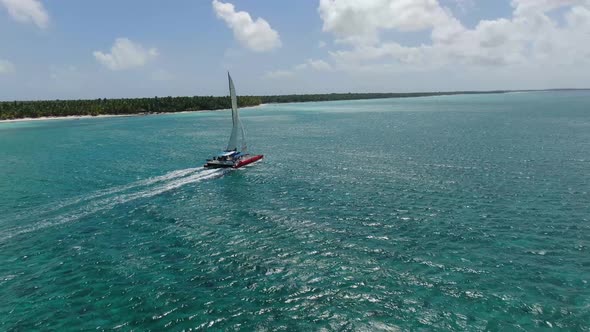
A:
318,0,590,70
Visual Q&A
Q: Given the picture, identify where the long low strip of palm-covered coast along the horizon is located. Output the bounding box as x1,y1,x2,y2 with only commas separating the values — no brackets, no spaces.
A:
0,89,590,123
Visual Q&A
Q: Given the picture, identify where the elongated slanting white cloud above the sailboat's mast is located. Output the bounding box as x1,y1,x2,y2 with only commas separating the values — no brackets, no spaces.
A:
212,0,281,52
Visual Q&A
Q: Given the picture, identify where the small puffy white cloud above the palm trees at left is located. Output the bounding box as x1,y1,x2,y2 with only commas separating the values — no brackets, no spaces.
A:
93,38,158,70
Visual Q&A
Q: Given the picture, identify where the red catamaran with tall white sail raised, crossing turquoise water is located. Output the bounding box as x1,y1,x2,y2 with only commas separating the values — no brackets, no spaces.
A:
203,73,264,168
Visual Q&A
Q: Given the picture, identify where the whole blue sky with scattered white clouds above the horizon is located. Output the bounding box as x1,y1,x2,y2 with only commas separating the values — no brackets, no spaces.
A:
0,0,590,100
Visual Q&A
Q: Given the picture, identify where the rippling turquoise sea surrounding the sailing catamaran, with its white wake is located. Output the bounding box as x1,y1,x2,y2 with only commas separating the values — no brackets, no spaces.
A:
0,92,590,331
